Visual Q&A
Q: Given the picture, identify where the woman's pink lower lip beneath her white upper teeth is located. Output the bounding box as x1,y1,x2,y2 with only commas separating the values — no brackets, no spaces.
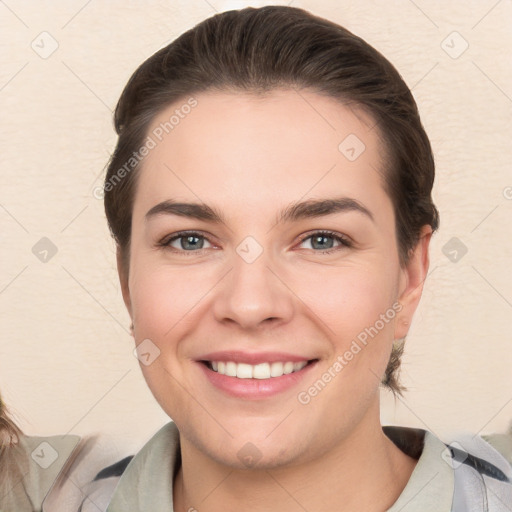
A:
198,361,316,400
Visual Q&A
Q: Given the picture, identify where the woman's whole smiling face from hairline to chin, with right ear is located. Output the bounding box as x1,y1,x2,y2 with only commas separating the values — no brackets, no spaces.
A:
121,90,429,467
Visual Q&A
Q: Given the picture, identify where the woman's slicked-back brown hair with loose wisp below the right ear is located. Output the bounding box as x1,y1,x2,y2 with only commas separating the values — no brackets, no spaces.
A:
104,6,439,394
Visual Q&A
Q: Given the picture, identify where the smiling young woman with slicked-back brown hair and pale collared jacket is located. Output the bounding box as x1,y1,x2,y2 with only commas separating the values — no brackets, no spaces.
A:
90,6,512,512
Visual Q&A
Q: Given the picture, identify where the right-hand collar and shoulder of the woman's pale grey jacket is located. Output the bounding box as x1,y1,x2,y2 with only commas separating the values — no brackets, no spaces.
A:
383,427,512,512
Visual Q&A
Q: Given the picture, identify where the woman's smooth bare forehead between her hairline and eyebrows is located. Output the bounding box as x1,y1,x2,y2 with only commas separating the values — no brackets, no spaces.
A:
134,89,392,222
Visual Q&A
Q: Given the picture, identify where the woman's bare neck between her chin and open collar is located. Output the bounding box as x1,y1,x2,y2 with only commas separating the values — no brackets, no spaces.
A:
174,407,417,512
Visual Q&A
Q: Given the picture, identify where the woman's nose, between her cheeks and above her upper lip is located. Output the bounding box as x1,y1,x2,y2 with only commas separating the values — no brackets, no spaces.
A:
213,245,293,330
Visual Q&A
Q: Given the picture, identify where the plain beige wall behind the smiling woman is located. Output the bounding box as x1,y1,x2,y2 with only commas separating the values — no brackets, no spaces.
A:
0,0,512,456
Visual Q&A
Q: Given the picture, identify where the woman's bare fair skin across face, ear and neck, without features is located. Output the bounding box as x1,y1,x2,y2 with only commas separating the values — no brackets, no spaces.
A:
118,90,431,512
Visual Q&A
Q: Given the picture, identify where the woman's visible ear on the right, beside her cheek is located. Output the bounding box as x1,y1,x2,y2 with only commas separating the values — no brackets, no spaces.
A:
395,225,432,339
